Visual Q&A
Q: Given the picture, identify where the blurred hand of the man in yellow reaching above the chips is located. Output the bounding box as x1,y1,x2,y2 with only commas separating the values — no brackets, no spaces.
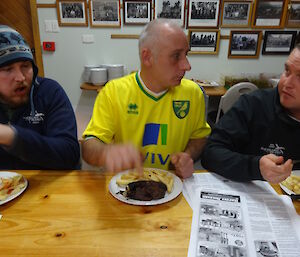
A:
104,144,143,174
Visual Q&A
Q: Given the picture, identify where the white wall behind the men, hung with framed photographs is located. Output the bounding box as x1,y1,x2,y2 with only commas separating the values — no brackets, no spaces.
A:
37,0,287,136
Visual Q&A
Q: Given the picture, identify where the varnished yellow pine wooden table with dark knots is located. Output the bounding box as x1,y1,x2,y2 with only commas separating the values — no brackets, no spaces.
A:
0,171,300,257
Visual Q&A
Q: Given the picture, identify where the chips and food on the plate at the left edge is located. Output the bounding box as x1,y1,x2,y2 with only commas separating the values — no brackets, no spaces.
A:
0,174,25,201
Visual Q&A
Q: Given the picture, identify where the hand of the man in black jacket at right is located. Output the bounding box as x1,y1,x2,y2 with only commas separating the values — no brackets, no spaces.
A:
259,154,293,183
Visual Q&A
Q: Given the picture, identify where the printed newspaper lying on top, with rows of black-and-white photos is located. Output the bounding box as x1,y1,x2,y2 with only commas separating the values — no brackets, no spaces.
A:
188,187,300,257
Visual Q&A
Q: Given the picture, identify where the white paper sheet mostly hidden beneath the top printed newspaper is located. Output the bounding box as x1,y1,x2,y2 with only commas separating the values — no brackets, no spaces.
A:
183,172,276,209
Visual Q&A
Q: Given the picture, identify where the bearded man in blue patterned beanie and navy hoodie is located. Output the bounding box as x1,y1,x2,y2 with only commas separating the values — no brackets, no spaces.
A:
0,25,80,169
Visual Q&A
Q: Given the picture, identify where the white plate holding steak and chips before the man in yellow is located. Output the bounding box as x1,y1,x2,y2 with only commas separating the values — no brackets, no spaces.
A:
109,168,182,205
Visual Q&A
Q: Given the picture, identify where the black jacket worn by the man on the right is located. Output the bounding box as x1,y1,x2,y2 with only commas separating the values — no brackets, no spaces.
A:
201,88,300,181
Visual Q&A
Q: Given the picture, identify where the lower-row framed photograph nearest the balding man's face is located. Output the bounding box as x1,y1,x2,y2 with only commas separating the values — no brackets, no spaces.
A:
188,29,220,54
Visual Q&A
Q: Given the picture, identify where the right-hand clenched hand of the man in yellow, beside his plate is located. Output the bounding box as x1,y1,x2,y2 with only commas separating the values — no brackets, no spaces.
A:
171,152,194,178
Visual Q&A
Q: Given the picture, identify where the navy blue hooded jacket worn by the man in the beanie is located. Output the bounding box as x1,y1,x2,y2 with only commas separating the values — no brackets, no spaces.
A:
0,78,80,169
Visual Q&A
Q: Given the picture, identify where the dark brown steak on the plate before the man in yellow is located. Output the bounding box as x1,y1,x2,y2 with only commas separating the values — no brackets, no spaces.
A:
123,180,167,201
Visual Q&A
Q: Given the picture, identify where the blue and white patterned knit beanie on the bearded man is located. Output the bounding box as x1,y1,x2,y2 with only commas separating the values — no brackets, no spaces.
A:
0,25,37,77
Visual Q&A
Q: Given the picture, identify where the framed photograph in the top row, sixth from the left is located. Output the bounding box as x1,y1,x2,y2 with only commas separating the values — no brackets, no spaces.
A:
221,0,252,28
